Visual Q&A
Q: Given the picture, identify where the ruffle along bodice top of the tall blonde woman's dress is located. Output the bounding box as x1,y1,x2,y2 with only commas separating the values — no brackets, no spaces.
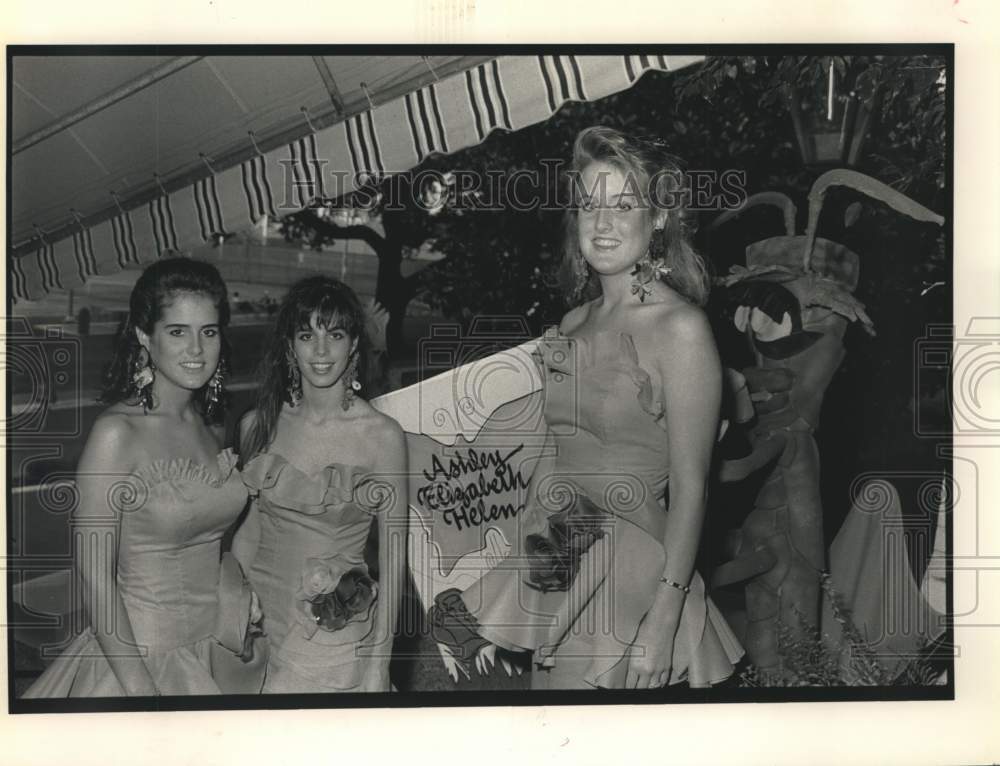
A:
535,331,665,421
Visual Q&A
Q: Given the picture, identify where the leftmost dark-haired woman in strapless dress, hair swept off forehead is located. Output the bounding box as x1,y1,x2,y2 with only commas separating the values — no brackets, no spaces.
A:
25,258,256,697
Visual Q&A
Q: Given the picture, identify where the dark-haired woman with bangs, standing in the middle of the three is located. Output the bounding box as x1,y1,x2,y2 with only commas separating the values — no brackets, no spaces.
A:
233,276,407,693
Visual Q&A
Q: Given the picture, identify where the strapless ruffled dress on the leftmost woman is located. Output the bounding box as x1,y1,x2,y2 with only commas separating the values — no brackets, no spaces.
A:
24,450,247,698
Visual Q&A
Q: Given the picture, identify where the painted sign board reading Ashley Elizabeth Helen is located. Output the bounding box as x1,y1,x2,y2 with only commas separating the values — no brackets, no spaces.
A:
372,341,548,682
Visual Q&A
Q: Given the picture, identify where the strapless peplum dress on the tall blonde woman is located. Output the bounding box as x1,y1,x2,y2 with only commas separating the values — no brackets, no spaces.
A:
461,332,743,689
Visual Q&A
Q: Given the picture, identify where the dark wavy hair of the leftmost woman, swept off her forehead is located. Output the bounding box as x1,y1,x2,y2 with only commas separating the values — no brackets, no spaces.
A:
98,256,230,425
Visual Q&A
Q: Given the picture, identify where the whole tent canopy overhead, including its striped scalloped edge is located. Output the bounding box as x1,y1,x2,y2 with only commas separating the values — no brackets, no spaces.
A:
8,52,702,300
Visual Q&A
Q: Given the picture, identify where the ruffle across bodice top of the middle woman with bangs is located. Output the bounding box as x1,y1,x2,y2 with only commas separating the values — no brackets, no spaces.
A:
243,453,389,515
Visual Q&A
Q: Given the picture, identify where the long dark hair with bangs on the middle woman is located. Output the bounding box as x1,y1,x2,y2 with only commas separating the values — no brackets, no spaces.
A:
240,275,367,464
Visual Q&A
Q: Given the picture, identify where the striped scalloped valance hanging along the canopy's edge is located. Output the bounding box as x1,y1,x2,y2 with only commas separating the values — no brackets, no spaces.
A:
8,55,704,301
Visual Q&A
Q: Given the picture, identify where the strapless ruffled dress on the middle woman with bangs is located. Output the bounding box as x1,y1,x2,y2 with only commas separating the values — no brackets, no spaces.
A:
243,453,385,693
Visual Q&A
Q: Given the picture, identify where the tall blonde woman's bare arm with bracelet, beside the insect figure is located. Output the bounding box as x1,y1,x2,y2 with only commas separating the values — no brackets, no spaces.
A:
627,306,722,688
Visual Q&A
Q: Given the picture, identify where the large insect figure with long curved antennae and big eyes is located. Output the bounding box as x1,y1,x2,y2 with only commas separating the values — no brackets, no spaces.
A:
713,170,944,676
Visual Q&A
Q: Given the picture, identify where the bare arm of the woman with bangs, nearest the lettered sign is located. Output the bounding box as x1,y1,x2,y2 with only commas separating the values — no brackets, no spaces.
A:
362,422,409,692
